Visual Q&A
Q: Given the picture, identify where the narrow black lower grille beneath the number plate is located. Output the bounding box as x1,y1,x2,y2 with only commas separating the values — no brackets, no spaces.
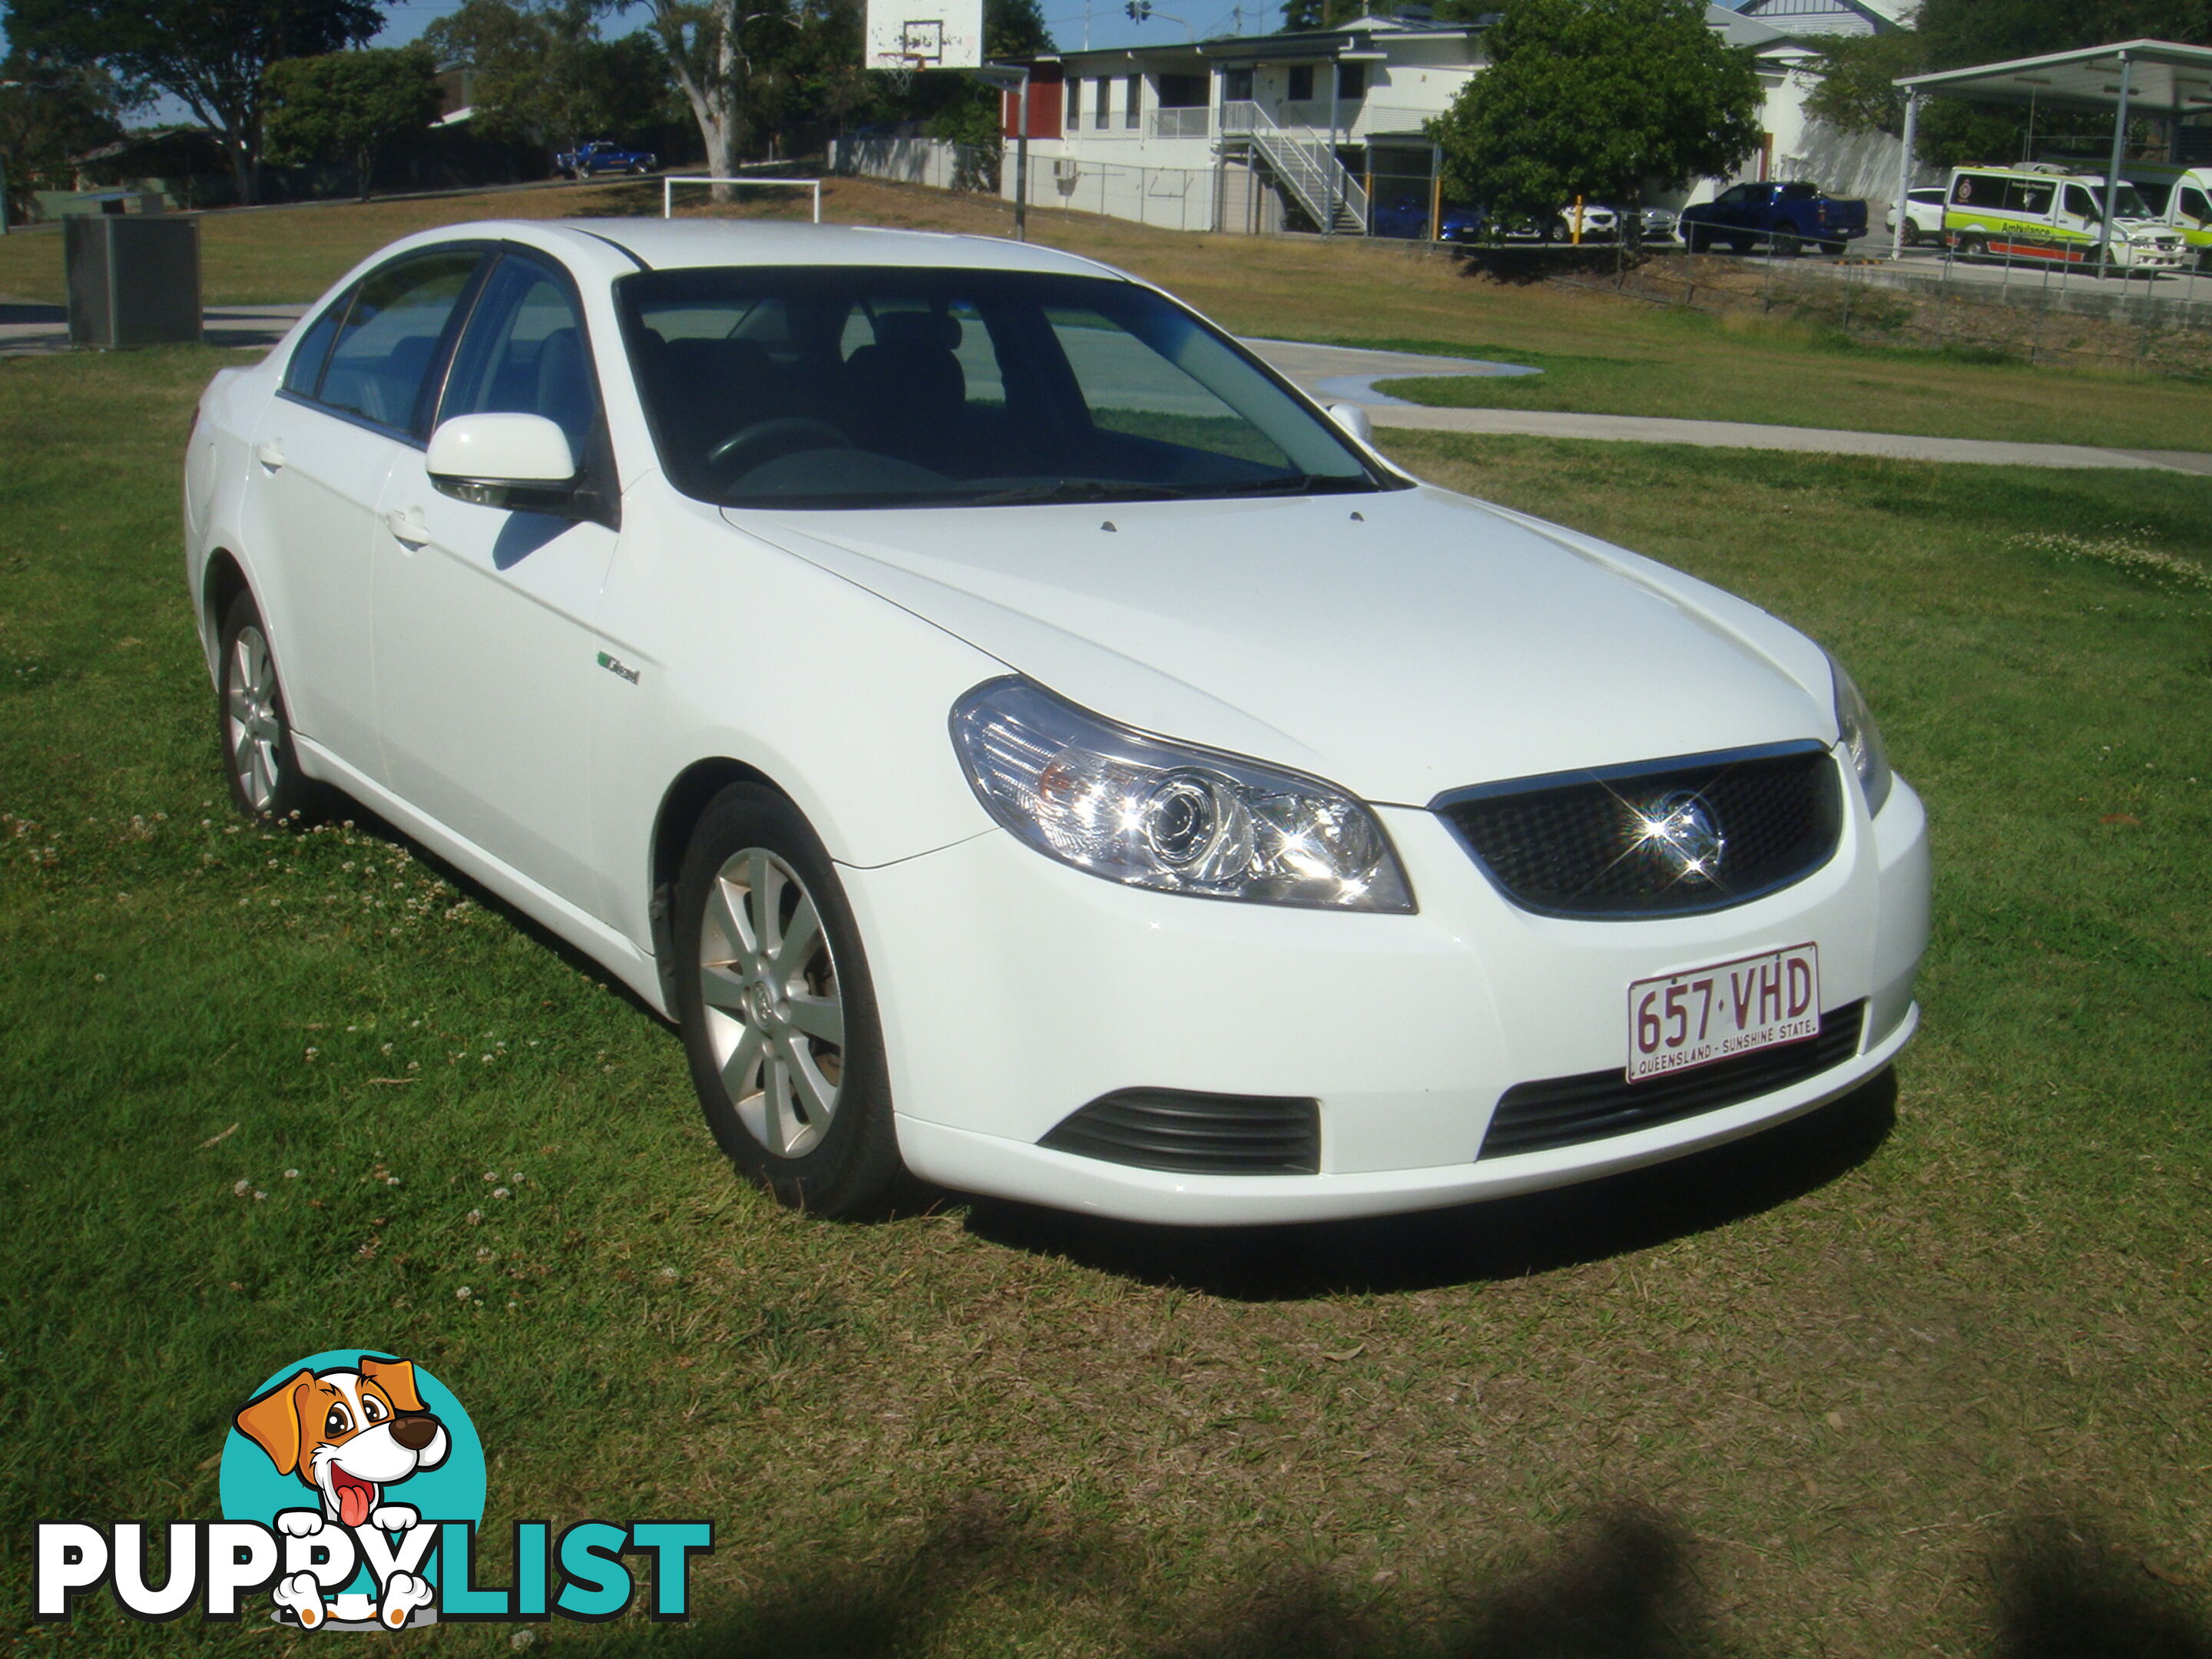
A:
1475,1002,1867,1159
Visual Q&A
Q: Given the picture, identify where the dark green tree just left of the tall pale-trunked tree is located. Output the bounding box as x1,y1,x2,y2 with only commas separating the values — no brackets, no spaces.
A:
422,0,668,148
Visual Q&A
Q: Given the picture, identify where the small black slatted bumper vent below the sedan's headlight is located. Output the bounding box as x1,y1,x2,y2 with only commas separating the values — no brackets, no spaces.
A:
1038,1088,1320,1174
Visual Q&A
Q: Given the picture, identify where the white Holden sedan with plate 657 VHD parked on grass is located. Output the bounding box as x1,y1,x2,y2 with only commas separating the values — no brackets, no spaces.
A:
186,219,1929,1224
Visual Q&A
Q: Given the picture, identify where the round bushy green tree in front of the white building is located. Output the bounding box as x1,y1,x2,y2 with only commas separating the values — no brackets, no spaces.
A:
1429,0,1760,214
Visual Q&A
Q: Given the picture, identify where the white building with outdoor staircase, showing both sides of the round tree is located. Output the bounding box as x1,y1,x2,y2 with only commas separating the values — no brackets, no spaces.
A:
1000,0,1929,234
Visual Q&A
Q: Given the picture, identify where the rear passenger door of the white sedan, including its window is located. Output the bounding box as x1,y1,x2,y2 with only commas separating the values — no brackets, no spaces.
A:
243,248,482,781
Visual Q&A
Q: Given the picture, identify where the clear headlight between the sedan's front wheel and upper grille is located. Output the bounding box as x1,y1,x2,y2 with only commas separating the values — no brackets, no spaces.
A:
951,679,1413,913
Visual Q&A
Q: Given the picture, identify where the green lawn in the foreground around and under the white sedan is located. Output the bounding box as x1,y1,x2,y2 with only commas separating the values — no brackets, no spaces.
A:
0,349,2212,1659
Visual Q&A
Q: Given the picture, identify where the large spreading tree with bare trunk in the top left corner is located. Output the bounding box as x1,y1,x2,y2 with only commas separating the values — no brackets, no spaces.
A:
5,0,385,201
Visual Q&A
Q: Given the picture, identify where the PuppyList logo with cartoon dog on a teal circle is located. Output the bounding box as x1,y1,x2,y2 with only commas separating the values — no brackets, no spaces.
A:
35,1349,714,1631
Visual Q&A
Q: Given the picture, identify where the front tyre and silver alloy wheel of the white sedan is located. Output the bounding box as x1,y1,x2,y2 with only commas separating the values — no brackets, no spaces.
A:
674,783,907,1219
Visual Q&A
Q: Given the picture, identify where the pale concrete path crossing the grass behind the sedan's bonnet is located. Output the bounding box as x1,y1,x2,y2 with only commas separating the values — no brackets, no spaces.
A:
1245,341,2212,475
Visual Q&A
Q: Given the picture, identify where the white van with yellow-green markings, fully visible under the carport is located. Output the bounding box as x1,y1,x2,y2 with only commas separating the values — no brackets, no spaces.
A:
1942,164,2190,272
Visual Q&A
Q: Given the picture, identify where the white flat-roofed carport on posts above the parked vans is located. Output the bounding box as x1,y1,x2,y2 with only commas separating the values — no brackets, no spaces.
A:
1889,40,2212,266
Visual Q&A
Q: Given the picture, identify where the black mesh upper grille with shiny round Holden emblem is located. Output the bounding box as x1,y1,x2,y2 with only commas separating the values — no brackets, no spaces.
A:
1431,741,1843,918
